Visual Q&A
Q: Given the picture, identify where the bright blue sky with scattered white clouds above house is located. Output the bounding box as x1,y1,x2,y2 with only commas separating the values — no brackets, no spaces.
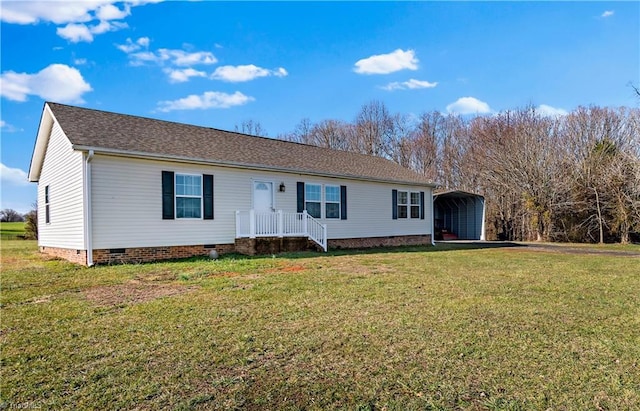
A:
0,0,640,212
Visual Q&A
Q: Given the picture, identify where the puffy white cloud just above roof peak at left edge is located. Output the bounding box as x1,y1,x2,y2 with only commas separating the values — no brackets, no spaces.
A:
0,64,92,103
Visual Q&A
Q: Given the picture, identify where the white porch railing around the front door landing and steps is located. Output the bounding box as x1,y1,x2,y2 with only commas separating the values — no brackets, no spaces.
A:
236,210,327,251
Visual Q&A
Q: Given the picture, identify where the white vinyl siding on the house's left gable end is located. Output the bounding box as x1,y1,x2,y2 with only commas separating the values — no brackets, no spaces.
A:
38,122,84,250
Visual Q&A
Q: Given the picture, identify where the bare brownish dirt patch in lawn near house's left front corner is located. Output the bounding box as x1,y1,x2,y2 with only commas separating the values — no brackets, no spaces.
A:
84,280,198,307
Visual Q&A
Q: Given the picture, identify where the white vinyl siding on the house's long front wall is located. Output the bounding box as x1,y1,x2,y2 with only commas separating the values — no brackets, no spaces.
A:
91,154,432,249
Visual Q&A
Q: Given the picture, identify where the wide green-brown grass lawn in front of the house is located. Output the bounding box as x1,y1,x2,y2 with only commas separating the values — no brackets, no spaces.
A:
0,241,640,410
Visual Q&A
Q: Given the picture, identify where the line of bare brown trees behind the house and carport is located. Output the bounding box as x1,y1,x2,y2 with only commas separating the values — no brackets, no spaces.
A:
272,101,640,243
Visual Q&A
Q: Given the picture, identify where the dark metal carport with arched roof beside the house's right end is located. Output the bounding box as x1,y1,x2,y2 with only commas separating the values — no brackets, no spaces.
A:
433,191,485,241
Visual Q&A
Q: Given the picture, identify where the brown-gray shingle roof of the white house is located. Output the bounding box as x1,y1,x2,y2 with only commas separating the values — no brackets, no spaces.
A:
47,103,432,185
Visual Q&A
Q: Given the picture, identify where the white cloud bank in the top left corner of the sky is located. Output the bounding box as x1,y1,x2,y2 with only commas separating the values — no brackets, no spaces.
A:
0,0,156,43
